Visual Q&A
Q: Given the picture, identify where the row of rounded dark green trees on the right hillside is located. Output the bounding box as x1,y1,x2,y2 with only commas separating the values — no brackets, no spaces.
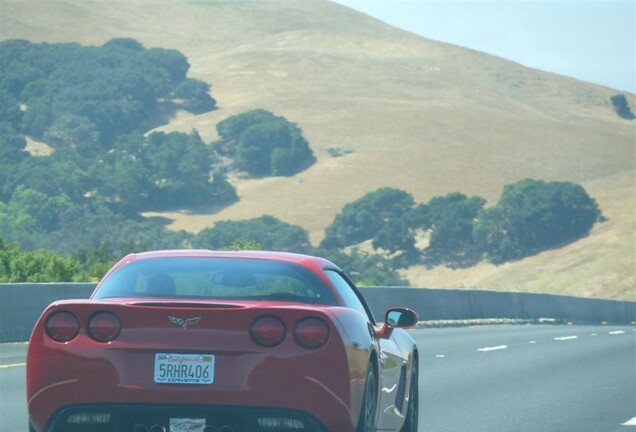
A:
321,179,602,266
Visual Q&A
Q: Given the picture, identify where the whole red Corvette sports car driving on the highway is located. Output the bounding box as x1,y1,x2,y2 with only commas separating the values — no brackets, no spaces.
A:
27,250,418,432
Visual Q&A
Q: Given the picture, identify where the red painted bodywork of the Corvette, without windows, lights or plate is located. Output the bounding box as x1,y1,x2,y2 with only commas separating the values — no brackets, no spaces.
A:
27,251,416,432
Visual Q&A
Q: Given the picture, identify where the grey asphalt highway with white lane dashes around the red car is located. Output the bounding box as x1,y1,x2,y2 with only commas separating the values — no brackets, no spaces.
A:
0,325,636,432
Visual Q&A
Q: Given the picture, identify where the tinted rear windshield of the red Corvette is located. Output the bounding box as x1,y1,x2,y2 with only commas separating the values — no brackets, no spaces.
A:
93,258,336,305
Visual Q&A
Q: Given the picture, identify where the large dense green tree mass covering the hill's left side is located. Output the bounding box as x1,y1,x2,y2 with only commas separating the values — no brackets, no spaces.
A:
0,39,315,252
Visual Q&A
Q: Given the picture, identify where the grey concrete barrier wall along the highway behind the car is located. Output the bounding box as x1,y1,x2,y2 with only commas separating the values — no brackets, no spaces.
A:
0,283,636,342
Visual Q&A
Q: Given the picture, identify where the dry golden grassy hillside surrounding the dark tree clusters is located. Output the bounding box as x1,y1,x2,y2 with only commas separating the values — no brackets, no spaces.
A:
0,0,636,299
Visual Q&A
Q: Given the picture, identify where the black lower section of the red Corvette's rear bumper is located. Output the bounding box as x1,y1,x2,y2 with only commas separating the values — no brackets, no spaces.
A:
36,404,327,432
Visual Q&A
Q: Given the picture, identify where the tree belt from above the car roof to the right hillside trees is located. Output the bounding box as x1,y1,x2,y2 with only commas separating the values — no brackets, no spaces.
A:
192,179,604,285
